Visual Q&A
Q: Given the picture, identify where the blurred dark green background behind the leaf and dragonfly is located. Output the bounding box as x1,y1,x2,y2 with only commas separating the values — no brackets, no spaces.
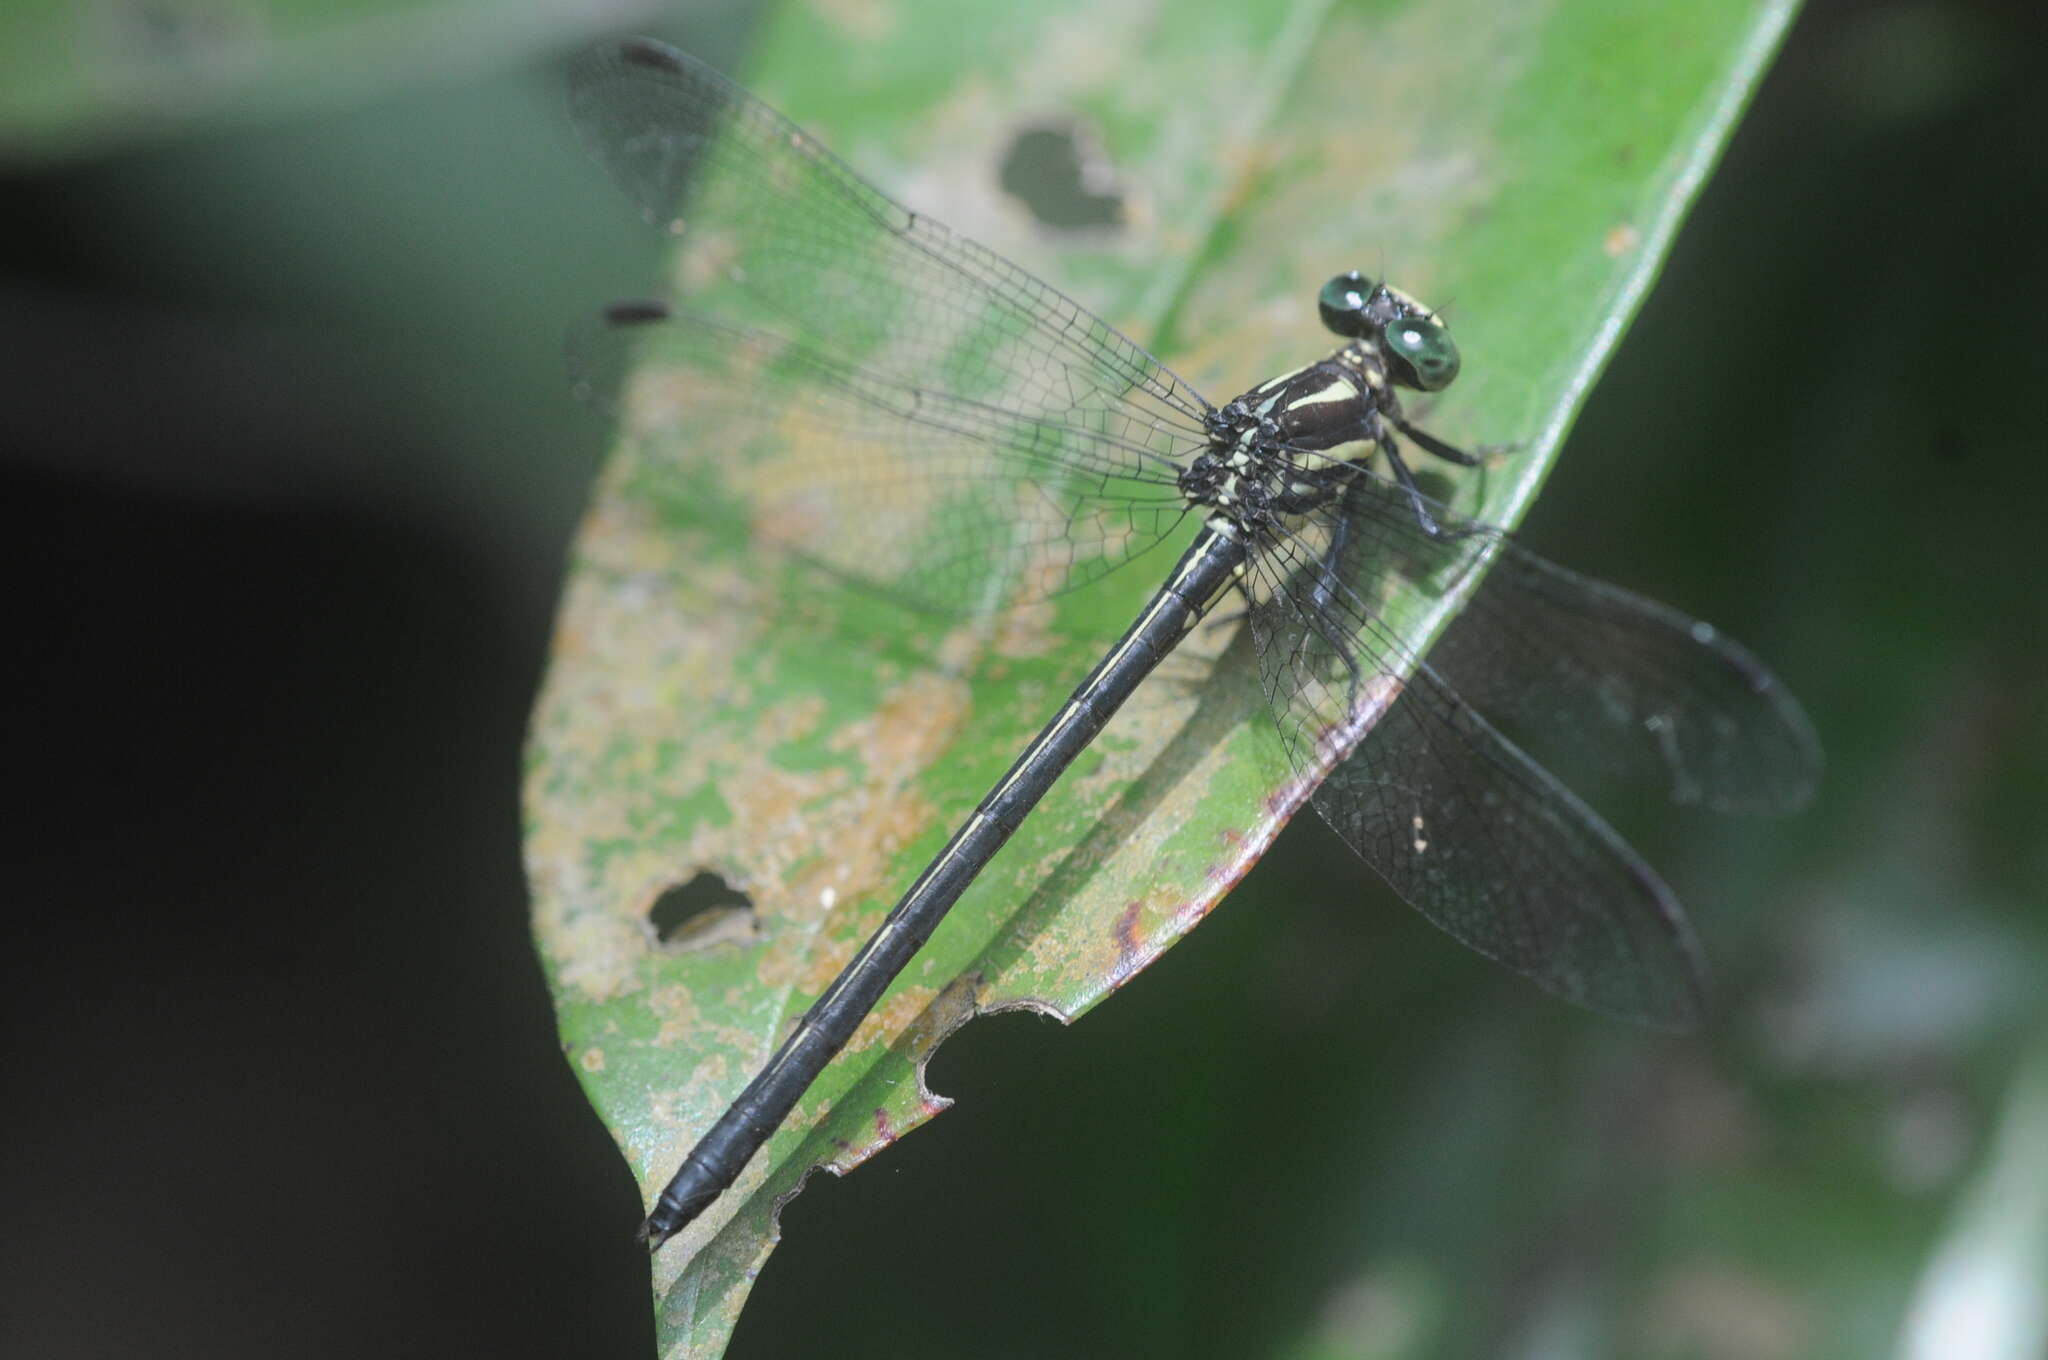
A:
0,0,2048,1358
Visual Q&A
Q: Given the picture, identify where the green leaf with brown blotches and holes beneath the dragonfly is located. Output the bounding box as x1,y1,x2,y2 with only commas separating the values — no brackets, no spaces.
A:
526,0,1792,1356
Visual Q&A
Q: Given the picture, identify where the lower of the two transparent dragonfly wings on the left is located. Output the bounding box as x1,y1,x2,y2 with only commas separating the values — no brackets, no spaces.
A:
569,303,1188,617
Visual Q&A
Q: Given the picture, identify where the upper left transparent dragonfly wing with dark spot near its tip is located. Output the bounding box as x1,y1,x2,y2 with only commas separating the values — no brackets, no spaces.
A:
569,39,1210,448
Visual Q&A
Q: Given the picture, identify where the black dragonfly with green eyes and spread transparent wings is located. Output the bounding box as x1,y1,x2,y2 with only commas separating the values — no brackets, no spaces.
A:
569,39,1821,1249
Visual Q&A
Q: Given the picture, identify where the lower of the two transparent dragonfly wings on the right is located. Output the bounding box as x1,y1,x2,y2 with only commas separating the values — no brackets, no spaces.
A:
1251,483,1706,1028
